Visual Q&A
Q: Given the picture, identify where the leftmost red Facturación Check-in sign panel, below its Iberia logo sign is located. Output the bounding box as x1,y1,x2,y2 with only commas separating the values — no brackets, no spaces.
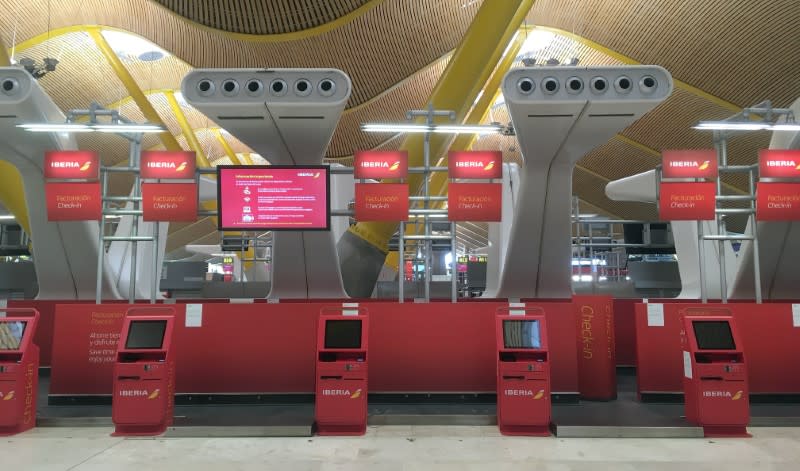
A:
44,183,103,221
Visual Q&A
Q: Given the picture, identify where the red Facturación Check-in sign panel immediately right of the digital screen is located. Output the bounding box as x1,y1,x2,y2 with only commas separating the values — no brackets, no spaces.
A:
355,183,408,221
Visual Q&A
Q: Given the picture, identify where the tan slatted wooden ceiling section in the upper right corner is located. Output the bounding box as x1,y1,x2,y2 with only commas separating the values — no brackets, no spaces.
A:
528,0,800,107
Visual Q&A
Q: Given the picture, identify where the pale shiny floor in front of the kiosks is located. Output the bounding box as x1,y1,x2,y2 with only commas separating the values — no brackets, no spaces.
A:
0,426,800,471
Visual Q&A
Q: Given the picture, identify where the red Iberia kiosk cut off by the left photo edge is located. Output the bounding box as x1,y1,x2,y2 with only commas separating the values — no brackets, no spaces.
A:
0,308,39,437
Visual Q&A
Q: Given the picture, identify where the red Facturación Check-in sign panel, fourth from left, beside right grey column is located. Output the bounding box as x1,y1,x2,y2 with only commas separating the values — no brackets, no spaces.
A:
447,183,503,222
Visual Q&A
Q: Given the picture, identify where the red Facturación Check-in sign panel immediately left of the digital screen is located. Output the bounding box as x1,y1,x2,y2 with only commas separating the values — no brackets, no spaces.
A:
142,183,197,222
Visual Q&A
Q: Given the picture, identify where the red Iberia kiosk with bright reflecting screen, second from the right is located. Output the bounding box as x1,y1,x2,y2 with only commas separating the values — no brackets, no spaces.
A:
496,308,551,436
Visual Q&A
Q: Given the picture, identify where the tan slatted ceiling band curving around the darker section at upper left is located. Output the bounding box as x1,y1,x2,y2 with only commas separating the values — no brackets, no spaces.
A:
0,0,481,106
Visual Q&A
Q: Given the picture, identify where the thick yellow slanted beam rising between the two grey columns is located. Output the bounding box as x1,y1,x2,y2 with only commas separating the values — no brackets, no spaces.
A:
349,0,534,252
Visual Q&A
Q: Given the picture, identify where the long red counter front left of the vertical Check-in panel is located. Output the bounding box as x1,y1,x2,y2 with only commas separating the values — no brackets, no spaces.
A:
50,302,578,396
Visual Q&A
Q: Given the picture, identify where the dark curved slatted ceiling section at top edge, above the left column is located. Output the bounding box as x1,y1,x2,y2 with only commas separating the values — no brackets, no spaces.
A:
154,0,369,34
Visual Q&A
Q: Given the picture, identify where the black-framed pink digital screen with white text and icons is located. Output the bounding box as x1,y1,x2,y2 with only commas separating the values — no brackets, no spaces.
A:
217,165,331,231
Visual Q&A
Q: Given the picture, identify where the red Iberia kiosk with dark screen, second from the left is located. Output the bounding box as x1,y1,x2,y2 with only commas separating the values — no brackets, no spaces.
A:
111,307,175,436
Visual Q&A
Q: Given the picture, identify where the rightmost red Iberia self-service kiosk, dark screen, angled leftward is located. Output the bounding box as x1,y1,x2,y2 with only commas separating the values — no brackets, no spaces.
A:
683,315,750,437
